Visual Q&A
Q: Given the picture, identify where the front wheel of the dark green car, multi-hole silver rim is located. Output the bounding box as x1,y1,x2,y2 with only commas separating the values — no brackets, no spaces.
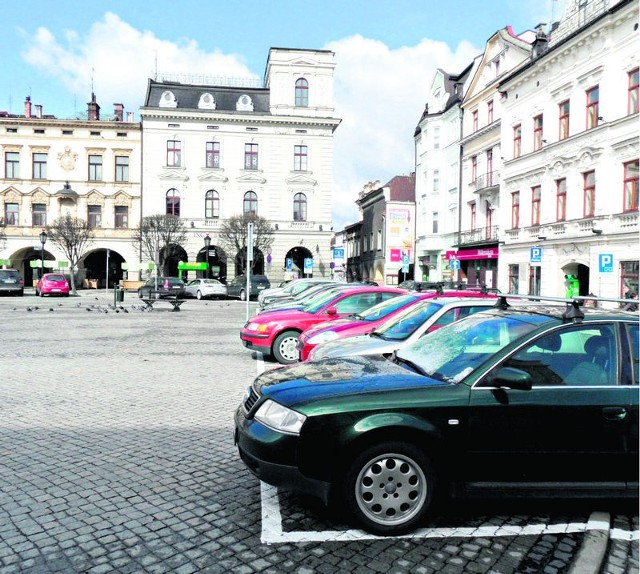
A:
342,441,435,536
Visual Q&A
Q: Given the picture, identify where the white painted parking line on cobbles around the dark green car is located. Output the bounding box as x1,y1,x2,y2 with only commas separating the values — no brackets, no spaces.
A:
256,353,640,544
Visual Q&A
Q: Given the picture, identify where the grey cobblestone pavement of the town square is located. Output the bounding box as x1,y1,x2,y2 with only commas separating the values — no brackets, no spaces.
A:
0,291,638,574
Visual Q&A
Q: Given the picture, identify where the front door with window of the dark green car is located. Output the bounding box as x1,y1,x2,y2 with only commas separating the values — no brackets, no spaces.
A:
465,323,632,488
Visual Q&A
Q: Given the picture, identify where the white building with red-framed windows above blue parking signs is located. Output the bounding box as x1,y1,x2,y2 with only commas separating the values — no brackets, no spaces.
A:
499,0,640,297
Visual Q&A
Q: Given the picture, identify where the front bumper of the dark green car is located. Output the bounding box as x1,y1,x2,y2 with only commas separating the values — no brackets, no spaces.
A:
234,407,330,504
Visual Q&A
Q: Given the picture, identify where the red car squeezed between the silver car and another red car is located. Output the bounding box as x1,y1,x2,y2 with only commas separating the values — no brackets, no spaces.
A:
298,289,496,361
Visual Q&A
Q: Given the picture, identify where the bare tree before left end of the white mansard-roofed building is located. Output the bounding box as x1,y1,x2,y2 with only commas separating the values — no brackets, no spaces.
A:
131,214,187,275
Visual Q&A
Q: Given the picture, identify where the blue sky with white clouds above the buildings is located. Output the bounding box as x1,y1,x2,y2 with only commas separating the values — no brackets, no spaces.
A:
0,0,561,230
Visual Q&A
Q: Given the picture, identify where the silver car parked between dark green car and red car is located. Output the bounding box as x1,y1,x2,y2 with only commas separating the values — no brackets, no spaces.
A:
310,297,497,361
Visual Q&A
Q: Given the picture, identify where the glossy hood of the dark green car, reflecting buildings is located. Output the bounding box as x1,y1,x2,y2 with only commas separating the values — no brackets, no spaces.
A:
254,356,450,407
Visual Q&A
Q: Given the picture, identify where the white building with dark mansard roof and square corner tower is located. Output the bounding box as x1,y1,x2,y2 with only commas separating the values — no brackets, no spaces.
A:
141,48,340,282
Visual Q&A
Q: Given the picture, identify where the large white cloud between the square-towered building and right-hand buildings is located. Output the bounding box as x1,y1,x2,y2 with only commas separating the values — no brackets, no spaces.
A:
327,36,479,229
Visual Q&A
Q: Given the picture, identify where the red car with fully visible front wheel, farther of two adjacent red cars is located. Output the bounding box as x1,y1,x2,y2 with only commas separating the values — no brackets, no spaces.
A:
240,286,407,365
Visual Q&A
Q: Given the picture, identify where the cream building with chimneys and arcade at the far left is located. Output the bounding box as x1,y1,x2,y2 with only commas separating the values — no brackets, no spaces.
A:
0,94,141,292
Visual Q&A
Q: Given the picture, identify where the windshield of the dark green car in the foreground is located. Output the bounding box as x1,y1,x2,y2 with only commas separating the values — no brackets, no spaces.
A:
395,313,549,383
